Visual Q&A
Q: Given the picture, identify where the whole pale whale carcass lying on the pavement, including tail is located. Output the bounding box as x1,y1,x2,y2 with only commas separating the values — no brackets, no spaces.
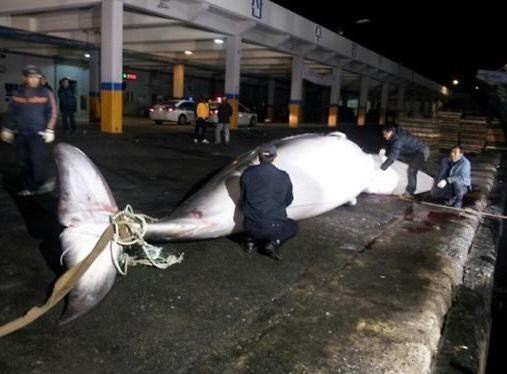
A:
55,132,433,321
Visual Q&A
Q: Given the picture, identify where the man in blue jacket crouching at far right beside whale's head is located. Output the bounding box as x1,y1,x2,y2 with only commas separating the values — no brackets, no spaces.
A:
431,145,472,208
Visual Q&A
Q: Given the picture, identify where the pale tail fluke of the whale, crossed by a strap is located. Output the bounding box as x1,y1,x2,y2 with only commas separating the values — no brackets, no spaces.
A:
55,143,121,323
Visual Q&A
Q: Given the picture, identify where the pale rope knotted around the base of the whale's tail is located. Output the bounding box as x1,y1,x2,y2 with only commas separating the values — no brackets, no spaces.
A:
111,204,183,275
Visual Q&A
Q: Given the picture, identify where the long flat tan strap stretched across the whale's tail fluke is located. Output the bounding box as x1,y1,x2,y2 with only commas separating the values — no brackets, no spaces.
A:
0,225,114,337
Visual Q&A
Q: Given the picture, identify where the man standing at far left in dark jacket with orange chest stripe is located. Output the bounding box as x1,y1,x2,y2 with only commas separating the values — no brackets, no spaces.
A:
1,65,57,196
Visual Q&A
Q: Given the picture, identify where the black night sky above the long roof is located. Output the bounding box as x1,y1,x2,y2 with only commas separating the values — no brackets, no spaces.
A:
273,0,507,86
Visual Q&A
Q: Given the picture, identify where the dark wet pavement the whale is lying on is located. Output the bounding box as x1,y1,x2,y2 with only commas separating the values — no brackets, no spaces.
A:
0,121,504,373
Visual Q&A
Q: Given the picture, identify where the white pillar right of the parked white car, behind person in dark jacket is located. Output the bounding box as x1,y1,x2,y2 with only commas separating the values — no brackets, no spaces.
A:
225,36,241,129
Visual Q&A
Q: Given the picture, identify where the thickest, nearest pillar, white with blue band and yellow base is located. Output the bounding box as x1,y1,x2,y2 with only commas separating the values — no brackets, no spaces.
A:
100,0,123,134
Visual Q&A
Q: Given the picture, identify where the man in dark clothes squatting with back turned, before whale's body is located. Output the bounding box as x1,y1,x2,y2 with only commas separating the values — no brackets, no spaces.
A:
240,145,298,260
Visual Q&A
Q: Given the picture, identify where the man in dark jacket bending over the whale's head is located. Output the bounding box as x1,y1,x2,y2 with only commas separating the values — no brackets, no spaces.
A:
380,125,430,200
